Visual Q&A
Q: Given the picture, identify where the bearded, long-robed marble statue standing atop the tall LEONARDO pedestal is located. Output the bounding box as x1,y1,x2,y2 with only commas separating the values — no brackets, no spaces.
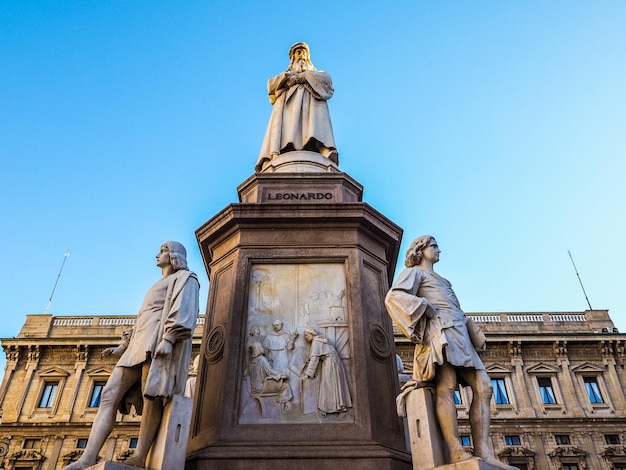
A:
255,42,339,172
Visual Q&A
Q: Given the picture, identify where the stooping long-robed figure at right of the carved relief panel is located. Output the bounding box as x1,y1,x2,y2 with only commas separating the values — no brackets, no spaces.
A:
304,328,352,413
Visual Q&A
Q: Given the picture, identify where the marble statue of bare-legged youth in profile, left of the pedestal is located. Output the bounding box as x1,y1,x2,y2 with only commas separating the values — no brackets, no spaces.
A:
66,241,199,470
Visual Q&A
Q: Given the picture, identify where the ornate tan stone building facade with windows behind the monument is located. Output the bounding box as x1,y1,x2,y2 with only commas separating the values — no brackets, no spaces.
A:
0,310,626,470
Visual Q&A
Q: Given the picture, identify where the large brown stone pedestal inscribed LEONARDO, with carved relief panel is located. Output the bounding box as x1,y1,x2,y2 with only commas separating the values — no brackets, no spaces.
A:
186,171,411,470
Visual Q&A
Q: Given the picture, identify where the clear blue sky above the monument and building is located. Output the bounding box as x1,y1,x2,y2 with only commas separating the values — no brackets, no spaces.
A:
0,0,626,370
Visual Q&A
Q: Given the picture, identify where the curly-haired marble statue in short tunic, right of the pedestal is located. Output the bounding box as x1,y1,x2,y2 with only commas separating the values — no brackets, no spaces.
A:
385,235,516,469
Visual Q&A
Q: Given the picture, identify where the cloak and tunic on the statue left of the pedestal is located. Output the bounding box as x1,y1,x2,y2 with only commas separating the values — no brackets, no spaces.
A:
116,270,199,408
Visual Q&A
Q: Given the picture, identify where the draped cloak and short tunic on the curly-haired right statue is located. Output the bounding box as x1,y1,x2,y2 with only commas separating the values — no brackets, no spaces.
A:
385,267,485,382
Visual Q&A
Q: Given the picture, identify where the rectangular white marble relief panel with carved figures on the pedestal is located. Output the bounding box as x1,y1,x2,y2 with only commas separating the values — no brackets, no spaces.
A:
239,263,354,424
